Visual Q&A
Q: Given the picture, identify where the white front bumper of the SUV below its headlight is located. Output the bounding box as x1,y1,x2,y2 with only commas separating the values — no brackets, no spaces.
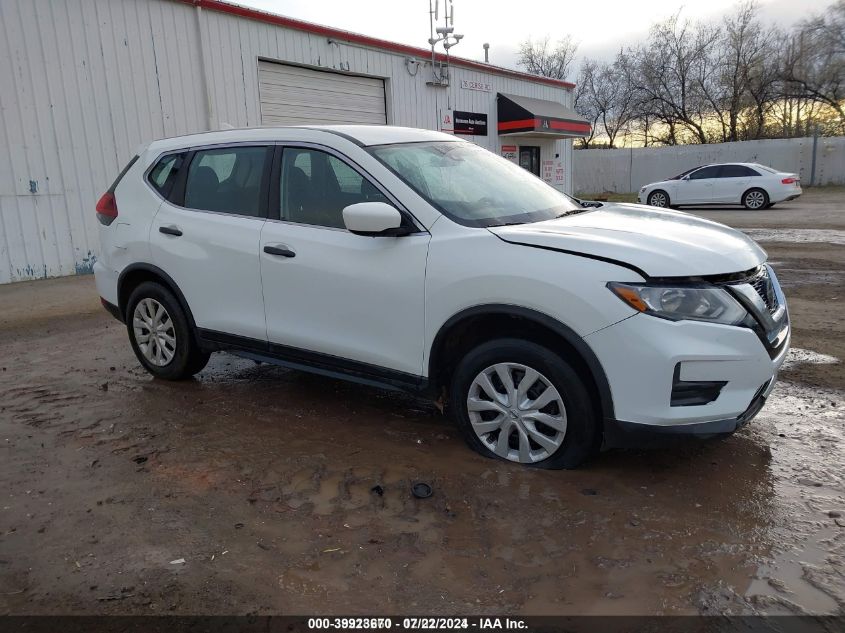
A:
585,314,789,444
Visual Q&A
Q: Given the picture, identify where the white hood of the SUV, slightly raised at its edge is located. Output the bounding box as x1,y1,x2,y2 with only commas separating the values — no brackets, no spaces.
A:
490,204,766,277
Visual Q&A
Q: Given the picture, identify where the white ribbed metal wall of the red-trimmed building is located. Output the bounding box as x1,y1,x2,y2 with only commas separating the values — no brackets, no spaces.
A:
0,0,572,283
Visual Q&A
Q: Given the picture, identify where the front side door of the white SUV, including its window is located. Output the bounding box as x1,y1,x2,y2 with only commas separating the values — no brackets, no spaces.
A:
260,145,431,377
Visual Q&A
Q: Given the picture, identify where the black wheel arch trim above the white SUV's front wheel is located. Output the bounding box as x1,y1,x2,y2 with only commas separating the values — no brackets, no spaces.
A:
428,303,615,419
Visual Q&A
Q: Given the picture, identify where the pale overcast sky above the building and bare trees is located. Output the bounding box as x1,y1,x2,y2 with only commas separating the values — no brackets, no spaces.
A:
229,0,833,79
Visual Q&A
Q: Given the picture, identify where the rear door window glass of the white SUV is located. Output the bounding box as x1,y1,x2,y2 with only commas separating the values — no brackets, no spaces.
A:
185,147,271,217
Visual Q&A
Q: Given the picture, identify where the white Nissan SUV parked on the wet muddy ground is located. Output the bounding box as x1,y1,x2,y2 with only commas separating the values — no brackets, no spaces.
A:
95,126,789,468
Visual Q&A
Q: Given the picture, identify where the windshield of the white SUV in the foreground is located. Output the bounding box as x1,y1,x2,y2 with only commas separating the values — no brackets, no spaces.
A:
370,141,585,226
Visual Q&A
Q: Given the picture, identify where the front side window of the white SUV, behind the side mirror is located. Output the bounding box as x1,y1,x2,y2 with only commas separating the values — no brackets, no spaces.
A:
280,147,389,229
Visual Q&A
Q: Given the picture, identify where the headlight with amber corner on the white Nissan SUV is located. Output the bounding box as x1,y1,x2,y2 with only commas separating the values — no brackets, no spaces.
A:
607,282,748,325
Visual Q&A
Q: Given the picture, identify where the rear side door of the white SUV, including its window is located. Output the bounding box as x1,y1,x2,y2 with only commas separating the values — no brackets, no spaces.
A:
150,144,273,344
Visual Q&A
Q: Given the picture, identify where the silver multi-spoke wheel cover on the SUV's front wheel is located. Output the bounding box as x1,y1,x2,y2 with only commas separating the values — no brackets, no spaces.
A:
467,363,566,464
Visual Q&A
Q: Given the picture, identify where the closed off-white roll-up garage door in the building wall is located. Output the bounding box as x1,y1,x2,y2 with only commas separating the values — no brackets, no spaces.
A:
258,61,387,125
